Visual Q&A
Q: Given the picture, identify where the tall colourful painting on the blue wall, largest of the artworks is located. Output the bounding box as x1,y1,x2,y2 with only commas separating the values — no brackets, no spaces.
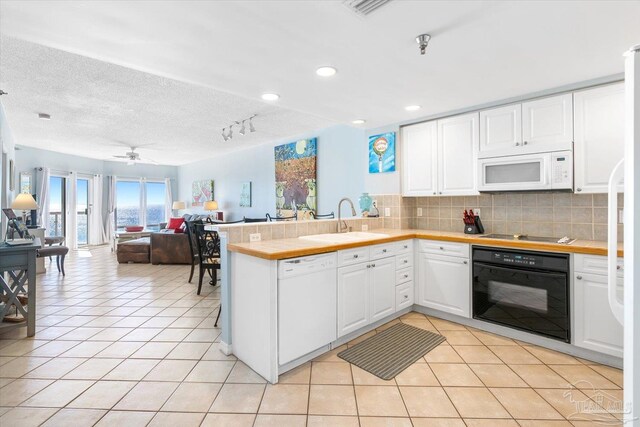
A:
274,138,318,219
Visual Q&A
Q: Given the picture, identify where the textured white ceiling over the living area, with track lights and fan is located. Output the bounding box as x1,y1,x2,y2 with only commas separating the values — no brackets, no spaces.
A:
0,36,332,165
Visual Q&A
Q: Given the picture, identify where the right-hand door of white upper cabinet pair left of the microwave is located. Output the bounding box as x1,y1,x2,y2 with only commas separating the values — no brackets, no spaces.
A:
438,113,478,196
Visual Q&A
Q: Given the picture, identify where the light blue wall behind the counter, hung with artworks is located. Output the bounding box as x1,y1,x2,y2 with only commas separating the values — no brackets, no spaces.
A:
178,125,367,221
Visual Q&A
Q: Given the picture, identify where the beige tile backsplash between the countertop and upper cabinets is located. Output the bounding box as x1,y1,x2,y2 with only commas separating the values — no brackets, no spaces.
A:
372,192,623,241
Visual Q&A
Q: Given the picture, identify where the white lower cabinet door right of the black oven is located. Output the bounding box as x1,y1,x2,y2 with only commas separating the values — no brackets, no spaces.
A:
573,272,624,357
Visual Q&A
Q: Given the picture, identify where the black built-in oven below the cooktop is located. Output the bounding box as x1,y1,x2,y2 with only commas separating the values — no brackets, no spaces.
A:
473,247,570,342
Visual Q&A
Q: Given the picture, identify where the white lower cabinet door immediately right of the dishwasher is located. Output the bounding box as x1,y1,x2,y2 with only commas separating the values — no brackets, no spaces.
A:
338,264,371,337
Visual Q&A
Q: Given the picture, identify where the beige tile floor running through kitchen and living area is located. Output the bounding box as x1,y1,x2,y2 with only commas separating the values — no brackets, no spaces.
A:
0,247,622,427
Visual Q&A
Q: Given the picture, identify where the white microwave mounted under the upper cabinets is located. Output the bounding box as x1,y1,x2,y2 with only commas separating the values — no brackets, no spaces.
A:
478,151,573,192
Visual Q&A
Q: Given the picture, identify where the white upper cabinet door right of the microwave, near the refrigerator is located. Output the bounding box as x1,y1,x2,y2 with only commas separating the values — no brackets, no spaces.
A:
573,83,624,193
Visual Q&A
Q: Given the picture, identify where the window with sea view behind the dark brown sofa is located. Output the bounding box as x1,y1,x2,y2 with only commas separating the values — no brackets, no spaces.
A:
116,179,166,230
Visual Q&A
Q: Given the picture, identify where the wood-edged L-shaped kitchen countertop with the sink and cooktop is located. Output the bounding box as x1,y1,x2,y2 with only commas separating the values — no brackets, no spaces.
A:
227,228,623,260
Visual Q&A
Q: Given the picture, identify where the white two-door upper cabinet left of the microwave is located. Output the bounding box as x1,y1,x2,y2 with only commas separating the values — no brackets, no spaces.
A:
401,113,478,196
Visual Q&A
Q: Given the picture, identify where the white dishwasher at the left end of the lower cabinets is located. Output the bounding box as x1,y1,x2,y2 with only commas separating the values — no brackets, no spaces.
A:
278,252,337,365
